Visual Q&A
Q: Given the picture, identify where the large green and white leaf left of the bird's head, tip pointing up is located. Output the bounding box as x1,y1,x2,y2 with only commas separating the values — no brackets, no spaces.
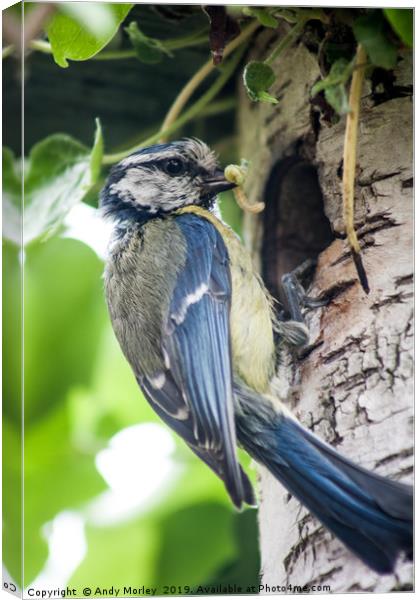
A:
3,120,103,245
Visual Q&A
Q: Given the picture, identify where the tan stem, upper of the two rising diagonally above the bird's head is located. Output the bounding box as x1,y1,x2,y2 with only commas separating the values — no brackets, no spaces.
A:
161,21,259,141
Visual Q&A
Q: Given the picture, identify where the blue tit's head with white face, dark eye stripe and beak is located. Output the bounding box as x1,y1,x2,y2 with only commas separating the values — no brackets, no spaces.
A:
100,139,234,221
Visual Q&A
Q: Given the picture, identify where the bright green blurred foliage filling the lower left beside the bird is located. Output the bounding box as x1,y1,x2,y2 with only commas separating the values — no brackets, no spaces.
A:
3,235,258,586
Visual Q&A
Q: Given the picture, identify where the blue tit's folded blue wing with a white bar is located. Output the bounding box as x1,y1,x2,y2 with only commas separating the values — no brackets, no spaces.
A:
140,214,252,506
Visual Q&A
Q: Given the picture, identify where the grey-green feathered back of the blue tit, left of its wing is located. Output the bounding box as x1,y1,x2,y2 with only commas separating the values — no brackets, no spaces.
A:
104,219,186,375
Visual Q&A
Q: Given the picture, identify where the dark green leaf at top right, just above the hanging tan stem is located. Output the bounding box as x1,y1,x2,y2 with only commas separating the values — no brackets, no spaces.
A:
353,11,397,69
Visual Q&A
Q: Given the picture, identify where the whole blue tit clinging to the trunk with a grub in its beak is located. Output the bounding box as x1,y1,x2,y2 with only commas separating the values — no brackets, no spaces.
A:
101,139,413,573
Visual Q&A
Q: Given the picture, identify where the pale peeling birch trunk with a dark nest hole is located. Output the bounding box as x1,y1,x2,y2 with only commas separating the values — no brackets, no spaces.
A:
239,33,413,592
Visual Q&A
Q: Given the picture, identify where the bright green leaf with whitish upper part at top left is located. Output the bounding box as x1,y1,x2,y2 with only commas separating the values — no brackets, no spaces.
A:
47,2,133,68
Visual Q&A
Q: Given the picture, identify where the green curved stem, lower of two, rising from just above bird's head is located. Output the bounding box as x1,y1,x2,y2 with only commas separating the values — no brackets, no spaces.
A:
102,46,245,165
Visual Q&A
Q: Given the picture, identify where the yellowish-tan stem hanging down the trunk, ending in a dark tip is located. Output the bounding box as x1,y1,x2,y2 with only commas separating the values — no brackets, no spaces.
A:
343,44,369,294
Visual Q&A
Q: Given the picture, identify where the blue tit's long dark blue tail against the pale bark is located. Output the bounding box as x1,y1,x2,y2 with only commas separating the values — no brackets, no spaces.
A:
235,385,413,573
